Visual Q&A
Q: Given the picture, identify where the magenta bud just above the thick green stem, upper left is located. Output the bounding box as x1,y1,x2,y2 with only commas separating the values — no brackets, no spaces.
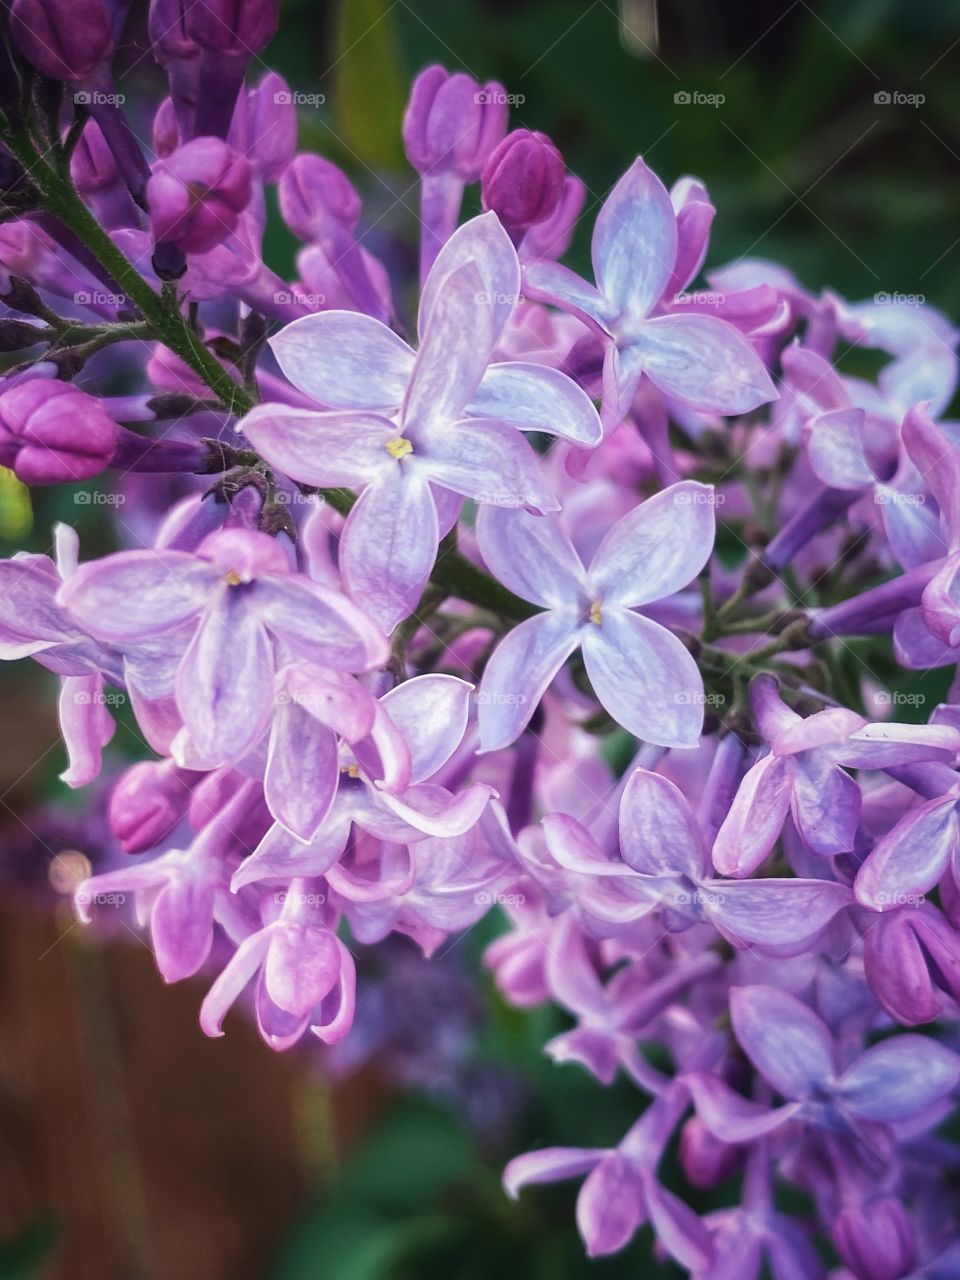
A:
147,138,252,253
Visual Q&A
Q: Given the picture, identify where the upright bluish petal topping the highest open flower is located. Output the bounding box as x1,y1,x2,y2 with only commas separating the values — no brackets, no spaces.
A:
591,157,677,317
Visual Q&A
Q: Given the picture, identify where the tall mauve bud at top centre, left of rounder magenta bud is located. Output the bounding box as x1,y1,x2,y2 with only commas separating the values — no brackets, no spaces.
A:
403,65,507,182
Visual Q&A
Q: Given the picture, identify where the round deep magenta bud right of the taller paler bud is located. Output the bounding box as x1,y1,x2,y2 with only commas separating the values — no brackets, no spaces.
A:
481,129,567,233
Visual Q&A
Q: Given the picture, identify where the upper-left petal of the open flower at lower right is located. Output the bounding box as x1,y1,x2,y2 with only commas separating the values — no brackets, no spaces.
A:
730,986,836,1102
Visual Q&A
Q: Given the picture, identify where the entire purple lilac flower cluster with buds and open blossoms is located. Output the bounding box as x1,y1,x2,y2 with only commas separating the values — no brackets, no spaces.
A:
0,0,960,1280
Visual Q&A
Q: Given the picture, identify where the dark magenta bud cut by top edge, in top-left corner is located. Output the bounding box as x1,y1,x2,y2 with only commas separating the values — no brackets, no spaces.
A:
10,0,127,81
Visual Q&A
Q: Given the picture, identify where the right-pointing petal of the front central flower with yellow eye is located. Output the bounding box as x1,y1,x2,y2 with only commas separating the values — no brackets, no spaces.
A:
415,417,559,512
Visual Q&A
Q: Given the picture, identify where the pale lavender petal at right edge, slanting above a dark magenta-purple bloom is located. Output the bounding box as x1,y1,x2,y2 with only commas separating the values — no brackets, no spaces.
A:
854,795,960,911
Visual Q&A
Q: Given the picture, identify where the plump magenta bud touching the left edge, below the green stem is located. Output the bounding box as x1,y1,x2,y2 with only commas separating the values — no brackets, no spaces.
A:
0,379,119,484
